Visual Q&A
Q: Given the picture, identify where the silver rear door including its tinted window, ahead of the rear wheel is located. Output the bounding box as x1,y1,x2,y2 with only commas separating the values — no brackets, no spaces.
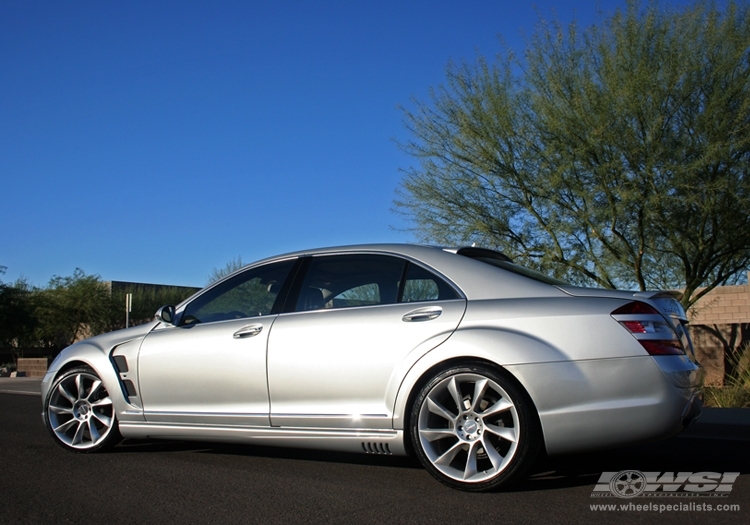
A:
268,254,466,428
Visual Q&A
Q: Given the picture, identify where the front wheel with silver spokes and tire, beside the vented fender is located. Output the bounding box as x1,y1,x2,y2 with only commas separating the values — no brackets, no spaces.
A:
44,368,121,452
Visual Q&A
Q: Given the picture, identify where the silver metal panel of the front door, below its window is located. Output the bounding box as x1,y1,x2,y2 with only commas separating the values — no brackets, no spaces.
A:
138,316,276,426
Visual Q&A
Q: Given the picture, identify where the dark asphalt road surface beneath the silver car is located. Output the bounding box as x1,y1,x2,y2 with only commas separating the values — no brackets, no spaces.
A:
0,393,750,525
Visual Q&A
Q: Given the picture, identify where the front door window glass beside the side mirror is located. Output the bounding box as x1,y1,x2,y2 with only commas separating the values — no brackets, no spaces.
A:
180,260,294,325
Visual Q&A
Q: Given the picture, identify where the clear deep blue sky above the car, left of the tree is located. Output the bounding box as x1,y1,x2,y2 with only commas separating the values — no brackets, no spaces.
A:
0,0,704,286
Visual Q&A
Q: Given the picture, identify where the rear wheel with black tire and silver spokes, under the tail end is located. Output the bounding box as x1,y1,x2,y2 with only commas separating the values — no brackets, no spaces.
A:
410,364,540,492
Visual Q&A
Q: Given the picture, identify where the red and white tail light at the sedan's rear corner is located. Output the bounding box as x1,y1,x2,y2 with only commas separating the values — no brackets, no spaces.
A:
612,301,685,355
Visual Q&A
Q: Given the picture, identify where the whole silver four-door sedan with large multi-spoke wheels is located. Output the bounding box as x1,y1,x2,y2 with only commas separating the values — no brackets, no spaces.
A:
42,245,701,491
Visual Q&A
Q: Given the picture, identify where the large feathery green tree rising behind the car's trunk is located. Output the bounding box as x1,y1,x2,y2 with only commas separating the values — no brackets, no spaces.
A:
396,1,750,307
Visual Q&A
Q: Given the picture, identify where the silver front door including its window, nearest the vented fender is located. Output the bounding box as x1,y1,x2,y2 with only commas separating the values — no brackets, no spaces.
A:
138,260,294,426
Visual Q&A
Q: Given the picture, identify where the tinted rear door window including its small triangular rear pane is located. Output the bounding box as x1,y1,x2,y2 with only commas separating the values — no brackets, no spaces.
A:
296,254,458,312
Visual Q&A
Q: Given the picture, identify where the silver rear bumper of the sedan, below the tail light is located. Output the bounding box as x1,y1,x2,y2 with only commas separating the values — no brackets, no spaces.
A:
507,356,702,455
